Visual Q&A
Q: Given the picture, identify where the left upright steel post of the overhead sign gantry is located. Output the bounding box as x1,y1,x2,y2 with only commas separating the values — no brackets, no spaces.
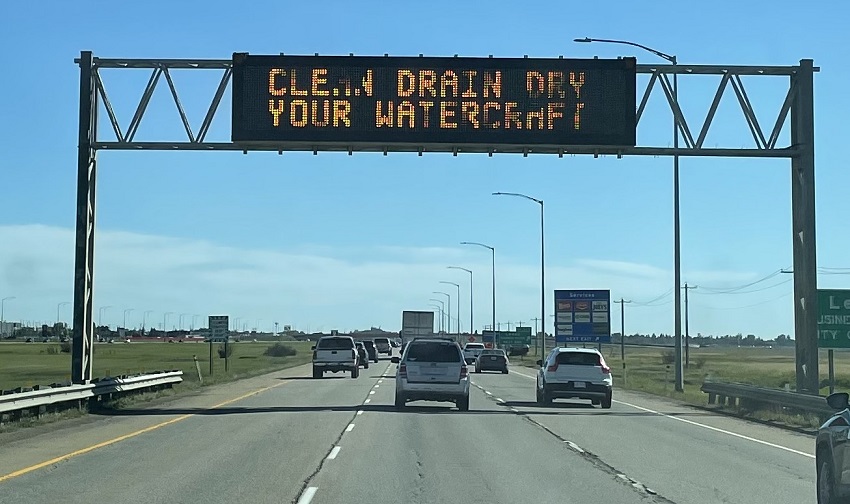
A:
71,51,97,384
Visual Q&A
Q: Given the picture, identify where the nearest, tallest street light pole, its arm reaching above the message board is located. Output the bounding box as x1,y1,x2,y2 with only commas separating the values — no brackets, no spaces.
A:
573,37,685,392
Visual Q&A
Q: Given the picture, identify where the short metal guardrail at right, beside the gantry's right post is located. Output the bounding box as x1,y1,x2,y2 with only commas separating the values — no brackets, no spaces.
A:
700,381,835,415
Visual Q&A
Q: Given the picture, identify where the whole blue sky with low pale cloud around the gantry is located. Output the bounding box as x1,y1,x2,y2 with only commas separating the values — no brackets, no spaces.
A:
0,0,850,337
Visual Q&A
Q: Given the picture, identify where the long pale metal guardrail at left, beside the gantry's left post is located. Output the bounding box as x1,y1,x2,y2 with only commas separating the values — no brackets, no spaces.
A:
0,371,183,415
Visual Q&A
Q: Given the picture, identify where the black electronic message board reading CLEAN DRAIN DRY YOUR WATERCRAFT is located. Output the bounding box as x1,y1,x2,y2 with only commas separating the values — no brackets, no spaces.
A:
232,53,636,152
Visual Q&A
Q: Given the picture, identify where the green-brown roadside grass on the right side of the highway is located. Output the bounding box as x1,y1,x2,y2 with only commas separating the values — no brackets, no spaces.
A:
511,344,850,427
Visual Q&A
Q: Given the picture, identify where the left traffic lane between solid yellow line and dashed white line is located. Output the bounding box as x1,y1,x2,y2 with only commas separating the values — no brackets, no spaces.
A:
0,366,390,503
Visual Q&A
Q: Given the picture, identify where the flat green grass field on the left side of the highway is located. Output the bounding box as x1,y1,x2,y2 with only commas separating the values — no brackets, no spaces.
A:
0,342,312,389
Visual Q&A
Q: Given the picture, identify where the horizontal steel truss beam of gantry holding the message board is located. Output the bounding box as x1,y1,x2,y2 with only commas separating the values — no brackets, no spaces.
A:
84,58,818,158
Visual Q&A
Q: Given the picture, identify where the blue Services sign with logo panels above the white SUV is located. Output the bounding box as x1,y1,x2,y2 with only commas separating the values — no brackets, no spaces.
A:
555,290,611,343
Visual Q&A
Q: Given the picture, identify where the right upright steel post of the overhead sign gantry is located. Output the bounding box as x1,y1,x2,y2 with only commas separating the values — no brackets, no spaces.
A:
790,59,819,395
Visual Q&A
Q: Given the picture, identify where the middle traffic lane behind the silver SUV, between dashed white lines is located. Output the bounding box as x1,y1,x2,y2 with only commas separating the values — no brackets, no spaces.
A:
302,368,663,504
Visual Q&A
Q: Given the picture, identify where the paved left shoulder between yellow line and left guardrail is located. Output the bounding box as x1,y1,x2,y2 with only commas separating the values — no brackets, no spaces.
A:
0,365,322,479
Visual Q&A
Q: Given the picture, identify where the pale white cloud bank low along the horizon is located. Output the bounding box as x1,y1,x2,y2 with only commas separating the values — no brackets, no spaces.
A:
0,225,791,334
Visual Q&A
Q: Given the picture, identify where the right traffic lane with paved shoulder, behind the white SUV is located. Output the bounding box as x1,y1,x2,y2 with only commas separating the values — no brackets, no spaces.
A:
475,373,815,504
